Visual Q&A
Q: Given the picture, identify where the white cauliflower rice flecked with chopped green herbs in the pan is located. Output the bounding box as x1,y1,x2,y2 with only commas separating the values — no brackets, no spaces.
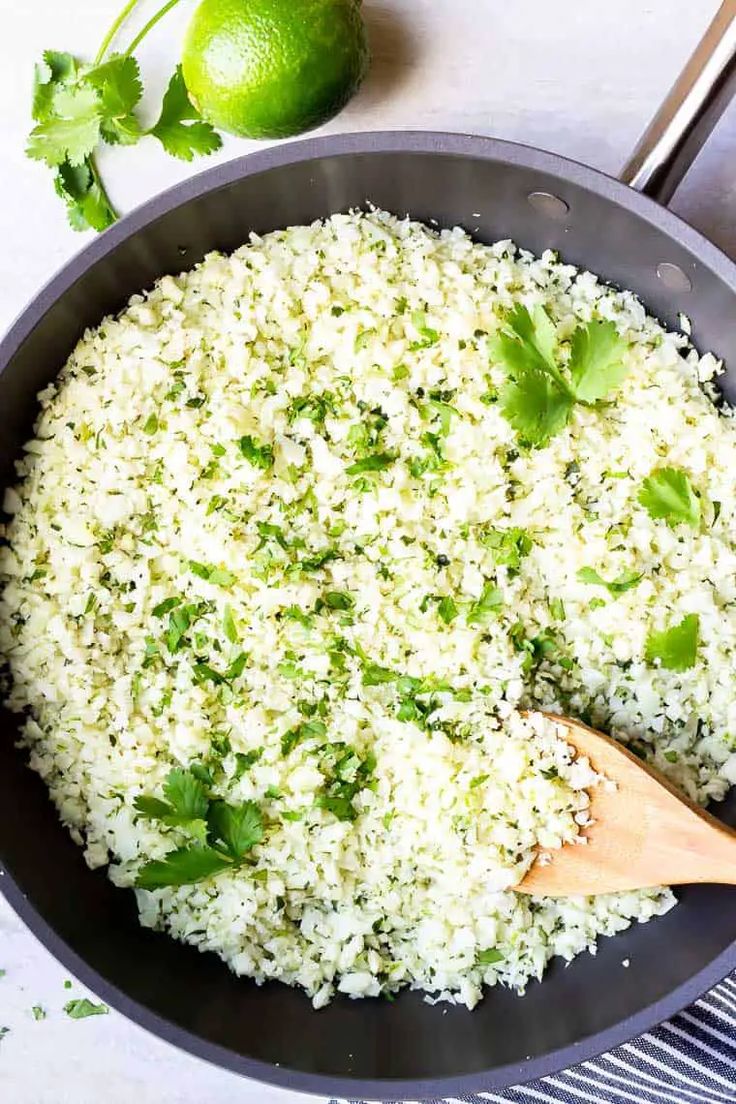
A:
0,212,736,1007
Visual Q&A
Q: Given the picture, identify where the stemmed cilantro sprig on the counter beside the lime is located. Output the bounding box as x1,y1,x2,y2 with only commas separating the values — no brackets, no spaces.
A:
26,0,222,231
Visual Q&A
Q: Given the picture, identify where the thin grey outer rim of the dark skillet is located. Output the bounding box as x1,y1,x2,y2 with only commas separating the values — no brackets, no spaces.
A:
0,130,736,1100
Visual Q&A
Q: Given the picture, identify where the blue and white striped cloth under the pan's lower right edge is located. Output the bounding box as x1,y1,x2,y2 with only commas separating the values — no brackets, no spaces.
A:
330,974,736,1104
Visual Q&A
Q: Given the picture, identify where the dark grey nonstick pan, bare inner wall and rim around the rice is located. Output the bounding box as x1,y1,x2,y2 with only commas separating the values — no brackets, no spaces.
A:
0,17,736,1100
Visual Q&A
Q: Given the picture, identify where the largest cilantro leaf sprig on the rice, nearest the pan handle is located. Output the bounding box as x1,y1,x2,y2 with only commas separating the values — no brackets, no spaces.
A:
489,304,628,447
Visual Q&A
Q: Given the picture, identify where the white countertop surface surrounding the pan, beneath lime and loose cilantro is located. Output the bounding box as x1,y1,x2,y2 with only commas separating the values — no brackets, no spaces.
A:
0,0,736,1104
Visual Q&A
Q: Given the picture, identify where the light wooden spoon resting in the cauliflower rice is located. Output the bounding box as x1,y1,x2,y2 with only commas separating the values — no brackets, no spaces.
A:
515,713,736,896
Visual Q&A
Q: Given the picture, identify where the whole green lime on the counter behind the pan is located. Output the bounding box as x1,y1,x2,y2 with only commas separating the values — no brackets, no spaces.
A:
182,0,369,138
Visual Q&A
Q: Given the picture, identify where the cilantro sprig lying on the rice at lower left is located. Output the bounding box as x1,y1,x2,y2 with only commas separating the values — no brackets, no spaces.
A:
134,767,264,890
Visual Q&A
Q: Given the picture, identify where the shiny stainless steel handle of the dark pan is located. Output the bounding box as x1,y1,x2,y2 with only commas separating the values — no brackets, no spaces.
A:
621,0,736,203
